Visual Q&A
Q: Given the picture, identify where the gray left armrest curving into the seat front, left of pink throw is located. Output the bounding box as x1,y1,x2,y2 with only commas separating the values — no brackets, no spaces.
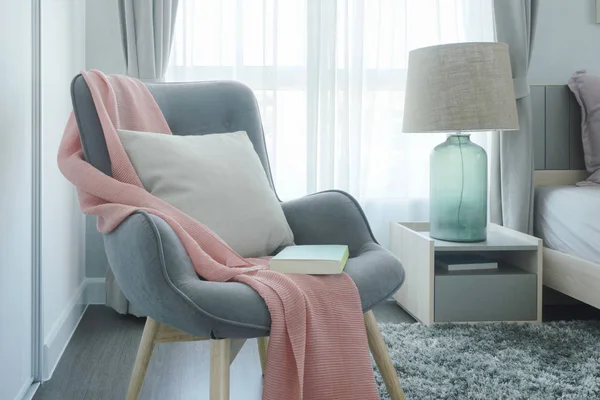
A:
104,211,271,338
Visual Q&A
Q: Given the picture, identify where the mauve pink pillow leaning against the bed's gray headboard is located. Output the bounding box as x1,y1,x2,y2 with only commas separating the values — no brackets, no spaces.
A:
569,70,600,184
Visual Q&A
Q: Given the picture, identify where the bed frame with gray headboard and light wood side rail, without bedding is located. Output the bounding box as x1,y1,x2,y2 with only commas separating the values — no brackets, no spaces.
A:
531,85,600,308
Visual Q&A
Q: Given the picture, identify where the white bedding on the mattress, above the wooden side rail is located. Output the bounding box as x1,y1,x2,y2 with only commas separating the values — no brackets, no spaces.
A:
534,186,600,263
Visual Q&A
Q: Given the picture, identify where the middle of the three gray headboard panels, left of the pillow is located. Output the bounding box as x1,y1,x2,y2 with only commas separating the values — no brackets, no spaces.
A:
546,86,570,170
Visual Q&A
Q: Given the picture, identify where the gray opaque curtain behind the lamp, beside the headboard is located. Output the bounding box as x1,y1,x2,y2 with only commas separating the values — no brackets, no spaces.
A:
490,0,539,233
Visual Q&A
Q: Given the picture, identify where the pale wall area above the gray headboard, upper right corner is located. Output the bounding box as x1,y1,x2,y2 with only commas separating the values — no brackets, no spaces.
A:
529,0,600,84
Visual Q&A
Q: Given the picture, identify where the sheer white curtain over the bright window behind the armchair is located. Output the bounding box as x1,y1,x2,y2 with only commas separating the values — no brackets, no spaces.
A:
166,0,494,244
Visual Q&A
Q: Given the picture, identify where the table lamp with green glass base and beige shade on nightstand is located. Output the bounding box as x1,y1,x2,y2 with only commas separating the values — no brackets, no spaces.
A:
402,43,519,242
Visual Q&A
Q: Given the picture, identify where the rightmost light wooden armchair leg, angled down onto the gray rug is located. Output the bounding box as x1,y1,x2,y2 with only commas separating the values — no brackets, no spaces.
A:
365,311,406,400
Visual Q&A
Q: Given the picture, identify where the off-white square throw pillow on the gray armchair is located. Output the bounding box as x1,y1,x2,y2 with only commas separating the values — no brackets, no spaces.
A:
117,130,294,257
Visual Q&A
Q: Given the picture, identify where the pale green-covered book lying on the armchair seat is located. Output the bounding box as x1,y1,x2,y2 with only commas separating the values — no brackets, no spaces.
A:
270,244,349,275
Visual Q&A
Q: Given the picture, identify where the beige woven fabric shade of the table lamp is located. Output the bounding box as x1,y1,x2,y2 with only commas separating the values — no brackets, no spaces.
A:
402,43,519,133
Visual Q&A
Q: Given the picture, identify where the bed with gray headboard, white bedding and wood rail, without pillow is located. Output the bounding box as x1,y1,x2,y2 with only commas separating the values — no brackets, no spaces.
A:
531,85,600,308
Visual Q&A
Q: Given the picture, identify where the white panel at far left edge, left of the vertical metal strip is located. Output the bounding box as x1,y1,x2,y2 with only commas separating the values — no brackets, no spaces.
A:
0,1,32,400
